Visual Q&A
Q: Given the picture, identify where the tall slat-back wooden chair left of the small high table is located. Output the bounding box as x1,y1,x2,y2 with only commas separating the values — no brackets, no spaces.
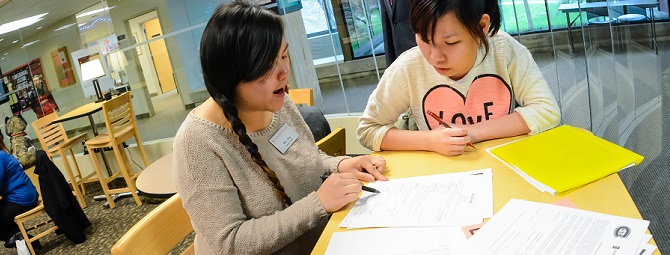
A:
32,112,95,208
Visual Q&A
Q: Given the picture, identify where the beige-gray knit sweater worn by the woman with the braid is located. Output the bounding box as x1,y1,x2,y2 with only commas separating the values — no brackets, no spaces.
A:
173,97,344,254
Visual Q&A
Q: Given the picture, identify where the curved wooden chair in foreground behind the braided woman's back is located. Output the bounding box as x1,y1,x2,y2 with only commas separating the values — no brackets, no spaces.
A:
112,194,195,255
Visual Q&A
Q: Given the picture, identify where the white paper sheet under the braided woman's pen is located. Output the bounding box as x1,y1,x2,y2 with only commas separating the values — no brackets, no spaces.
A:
340,168,493,228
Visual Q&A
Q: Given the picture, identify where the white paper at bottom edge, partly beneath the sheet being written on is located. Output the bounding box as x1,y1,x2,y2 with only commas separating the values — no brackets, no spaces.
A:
325,227,466,255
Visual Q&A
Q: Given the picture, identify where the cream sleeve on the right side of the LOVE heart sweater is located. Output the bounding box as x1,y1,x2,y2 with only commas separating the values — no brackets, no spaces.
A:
507,38,561,135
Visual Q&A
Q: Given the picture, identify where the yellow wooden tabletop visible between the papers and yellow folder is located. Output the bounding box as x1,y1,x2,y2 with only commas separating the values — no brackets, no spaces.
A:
312,137,660,254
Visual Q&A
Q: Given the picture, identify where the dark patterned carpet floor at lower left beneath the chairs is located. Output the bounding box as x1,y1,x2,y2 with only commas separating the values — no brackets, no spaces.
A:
0,181,194,255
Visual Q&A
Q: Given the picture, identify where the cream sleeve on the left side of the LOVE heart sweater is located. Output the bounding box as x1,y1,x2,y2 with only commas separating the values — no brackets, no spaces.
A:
356,63,410,151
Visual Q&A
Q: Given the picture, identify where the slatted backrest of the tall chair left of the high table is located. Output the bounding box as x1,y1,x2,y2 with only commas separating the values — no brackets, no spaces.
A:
31,112,69,156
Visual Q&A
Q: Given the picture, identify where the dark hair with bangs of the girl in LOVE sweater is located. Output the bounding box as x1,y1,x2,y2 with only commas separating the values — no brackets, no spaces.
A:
409,0,501,54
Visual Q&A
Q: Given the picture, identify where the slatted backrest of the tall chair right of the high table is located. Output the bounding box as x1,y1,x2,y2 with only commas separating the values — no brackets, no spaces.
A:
102,92,137,139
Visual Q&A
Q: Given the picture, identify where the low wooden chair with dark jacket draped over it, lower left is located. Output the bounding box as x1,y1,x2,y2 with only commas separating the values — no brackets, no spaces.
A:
14,167,58,255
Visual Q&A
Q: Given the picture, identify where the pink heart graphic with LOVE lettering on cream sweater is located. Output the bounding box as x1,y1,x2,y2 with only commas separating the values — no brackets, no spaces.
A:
423,74,512,129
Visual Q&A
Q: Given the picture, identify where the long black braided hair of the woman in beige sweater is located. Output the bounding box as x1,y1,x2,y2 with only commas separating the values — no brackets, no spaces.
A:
200,1,292,206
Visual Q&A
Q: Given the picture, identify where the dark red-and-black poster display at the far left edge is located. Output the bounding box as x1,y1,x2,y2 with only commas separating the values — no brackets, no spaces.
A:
3,58,58,118
